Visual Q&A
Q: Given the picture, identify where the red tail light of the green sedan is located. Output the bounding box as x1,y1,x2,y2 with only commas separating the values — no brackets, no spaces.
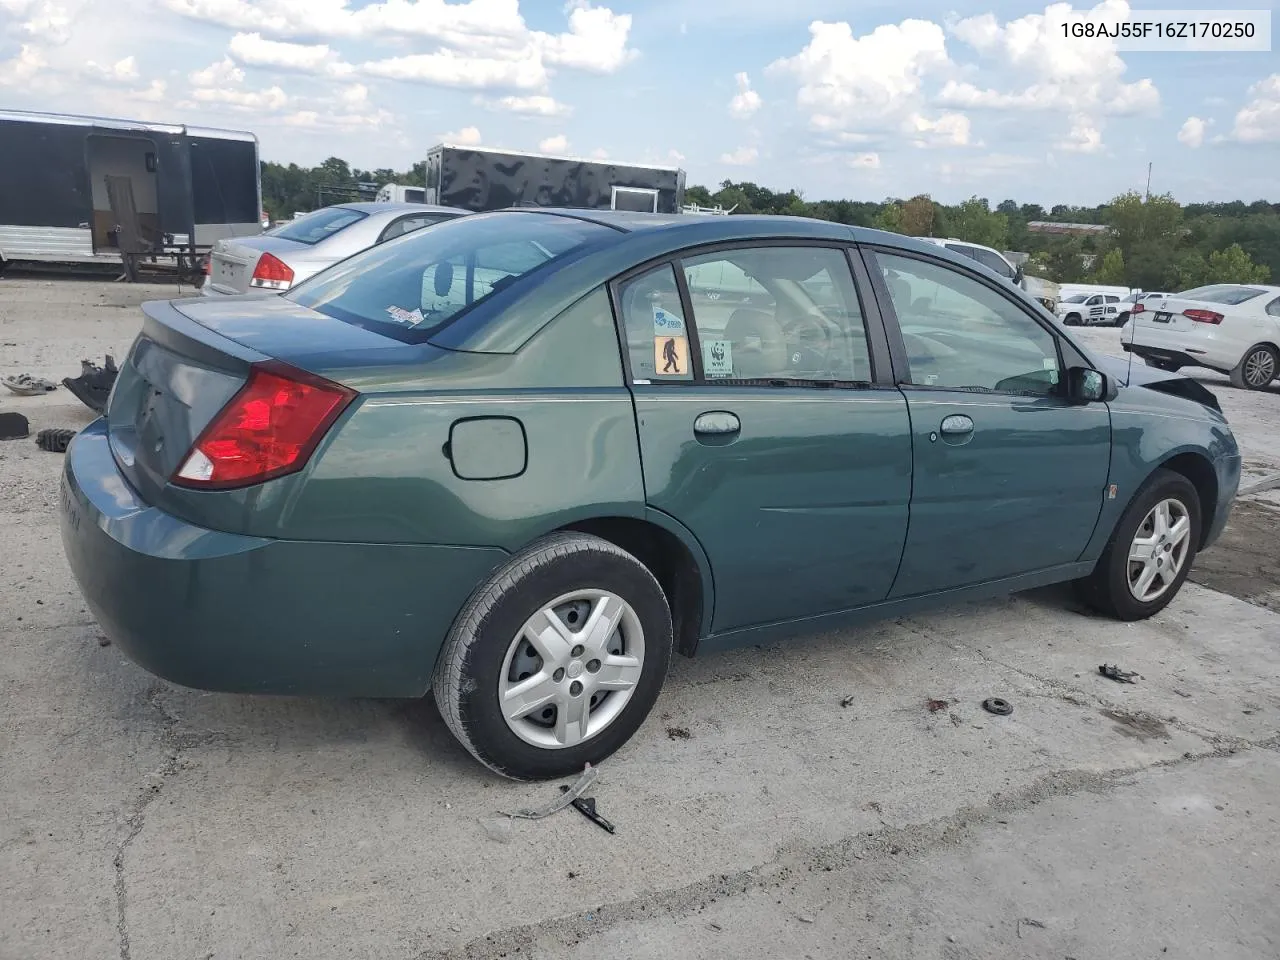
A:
173,364,356,489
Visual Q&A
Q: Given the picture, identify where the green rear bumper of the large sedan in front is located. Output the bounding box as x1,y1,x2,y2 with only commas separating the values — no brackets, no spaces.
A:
60,420,507,696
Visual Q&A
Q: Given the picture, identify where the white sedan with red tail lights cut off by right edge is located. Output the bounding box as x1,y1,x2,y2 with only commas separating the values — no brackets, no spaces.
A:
1120,283,1280,390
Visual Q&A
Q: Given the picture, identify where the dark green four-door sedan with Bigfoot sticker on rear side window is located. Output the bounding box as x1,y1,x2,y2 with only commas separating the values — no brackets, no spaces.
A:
61,209,1240,780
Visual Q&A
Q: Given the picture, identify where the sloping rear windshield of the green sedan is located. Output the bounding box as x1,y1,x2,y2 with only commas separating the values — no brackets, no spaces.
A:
285,214,617,343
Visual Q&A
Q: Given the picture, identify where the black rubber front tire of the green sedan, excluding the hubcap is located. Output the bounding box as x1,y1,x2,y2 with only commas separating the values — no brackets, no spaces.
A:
1076,468,1202,621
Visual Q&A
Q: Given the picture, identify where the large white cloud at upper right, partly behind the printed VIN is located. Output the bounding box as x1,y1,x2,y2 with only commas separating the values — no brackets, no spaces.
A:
938,0,1160,152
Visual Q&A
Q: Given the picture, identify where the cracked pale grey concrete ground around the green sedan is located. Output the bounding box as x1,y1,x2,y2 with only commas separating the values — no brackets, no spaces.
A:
0,280,1280,960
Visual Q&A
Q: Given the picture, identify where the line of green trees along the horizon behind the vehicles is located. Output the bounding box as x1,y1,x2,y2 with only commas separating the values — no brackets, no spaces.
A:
262,157,1280,291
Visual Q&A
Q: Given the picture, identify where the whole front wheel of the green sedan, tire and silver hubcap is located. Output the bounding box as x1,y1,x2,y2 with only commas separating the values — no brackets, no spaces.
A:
1078,468,1201,621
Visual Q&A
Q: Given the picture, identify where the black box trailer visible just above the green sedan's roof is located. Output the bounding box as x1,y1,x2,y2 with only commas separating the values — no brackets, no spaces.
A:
426,143,685,214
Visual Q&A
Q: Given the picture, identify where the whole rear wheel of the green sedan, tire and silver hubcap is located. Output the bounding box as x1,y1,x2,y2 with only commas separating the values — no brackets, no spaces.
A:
431,532,672,780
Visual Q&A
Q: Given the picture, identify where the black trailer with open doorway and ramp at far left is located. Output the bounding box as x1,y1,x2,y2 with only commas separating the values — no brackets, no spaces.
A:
0,111,262,276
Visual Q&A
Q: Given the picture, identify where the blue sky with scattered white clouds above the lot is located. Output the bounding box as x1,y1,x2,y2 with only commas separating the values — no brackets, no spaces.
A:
0,0,1280,206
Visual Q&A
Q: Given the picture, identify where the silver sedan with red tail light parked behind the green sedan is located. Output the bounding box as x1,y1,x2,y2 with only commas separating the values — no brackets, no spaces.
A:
200,202,466,297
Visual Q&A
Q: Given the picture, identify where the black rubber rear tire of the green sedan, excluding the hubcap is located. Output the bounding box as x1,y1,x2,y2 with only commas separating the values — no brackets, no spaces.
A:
456,549,672,780
